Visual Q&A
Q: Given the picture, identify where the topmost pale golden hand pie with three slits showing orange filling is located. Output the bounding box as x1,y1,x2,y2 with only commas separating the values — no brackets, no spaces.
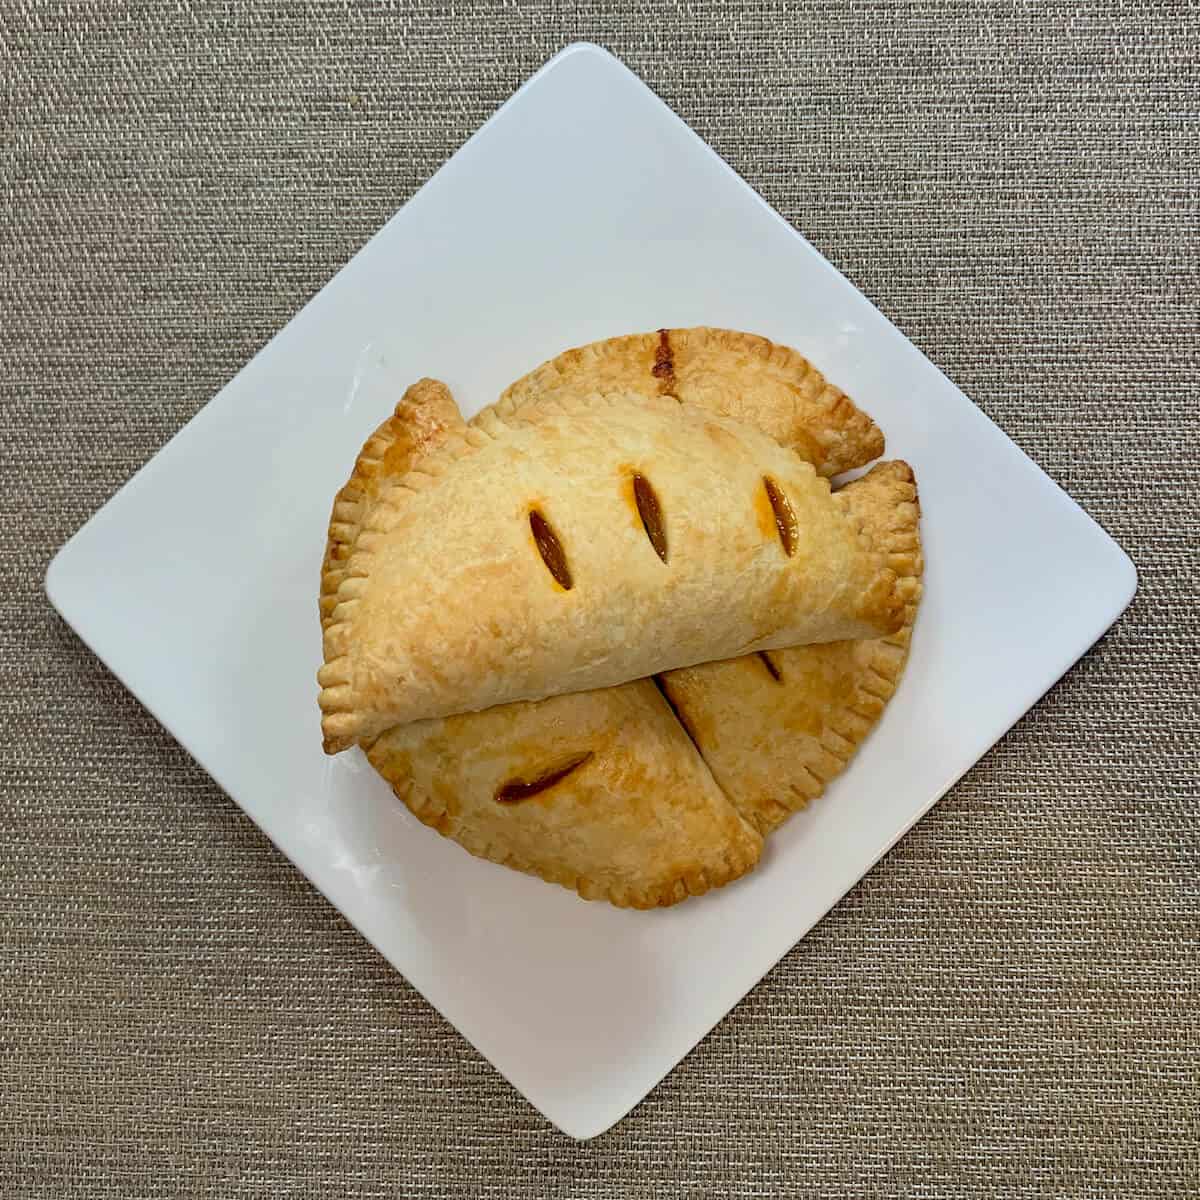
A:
318,394,904,752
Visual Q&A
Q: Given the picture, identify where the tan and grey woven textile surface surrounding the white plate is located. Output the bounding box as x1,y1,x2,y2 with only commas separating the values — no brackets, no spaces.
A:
0,0,1200,1198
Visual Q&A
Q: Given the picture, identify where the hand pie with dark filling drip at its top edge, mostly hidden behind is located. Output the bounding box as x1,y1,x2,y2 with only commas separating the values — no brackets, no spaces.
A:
496,325,883,475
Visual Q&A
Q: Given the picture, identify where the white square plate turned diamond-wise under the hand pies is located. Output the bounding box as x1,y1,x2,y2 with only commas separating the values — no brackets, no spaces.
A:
46,46,1135,1138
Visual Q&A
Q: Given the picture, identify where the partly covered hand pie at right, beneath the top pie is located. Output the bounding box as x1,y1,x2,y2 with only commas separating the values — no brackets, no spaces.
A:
660,462,922,834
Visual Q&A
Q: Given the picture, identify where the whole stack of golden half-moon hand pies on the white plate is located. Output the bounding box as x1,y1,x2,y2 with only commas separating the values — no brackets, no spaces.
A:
318,328,922,908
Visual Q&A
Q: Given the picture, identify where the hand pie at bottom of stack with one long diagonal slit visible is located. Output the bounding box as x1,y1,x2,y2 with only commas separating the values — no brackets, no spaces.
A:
367,679,762,908
